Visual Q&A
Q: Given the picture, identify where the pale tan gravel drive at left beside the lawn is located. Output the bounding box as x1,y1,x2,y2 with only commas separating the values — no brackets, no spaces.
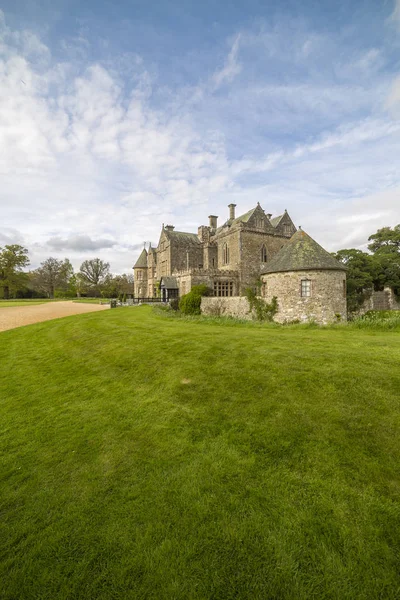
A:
0,302,110,331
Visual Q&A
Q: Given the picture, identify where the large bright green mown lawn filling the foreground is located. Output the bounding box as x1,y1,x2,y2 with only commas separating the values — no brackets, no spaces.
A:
0,307,400,600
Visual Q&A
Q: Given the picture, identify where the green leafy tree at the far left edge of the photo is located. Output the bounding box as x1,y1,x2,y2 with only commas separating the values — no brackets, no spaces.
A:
0,244,29,299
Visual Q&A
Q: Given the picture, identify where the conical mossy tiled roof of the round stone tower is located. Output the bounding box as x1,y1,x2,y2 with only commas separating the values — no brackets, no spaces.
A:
262,229,347,274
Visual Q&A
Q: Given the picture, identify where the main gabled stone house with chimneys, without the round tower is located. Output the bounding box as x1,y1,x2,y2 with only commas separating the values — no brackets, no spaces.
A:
134,204,296,299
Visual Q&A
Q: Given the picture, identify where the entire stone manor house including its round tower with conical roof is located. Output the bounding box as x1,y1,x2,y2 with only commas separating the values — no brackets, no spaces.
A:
133,204,346,322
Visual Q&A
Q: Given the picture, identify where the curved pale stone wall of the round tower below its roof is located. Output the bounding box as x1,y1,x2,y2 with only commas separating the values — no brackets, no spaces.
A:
262,270,347,324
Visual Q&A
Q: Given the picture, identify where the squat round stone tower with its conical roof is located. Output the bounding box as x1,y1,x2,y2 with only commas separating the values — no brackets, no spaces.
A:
261,229,347,324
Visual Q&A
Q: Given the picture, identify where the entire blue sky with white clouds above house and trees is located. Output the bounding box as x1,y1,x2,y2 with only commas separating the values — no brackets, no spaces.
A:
0,0,400,273
